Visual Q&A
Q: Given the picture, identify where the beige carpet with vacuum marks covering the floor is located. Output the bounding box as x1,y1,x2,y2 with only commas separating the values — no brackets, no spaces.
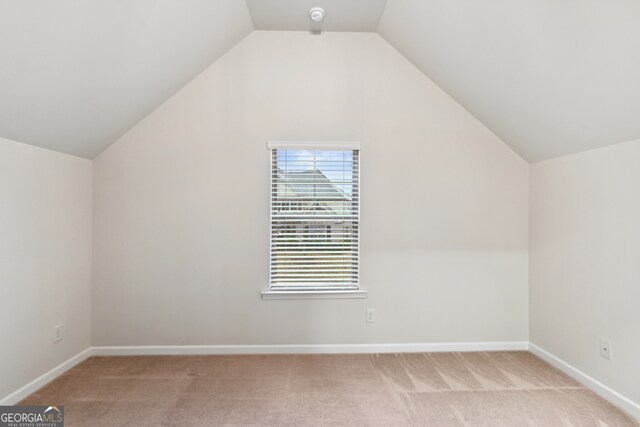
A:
21,352,640,427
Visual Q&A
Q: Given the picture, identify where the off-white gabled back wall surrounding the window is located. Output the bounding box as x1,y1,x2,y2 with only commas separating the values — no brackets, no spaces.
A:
93,32,528,345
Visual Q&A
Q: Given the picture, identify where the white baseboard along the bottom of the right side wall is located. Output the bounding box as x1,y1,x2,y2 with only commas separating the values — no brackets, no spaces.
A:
529,343,640,420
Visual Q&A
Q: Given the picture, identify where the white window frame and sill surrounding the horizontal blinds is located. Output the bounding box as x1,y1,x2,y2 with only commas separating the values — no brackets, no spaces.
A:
261,141,367,300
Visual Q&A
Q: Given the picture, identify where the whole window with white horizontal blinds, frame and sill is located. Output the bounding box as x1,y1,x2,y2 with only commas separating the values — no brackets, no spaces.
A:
263,142,365,298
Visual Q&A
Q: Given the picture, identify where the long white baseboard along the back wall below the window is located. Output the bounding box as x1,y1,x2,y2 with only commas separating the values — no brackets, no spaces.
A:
93,341,529,356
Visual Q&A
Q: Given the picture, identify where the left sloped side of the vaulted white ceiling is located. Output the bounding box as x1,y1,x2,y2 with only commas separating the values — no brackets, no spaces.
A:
0,0,253,158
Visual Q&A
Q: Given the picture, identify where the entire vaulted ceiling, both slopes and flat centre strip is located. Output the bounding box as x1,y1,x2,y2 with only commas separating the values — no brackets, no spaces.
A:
0,0,640,161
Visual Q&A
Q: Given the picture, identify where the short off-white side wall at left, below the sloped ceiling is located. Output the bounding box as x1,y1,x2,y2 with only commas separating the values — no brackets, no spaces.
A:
0,138,92,399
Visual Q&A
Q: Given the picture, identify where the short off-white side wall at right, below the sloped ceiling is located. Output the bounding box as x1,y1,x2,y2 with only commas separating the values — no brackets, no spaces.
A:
530,140,640,402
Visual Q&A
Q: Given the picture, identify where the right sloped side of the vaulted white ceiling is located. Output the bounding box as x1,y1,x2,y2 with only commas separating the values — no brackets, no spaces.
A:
378,0,640,162
